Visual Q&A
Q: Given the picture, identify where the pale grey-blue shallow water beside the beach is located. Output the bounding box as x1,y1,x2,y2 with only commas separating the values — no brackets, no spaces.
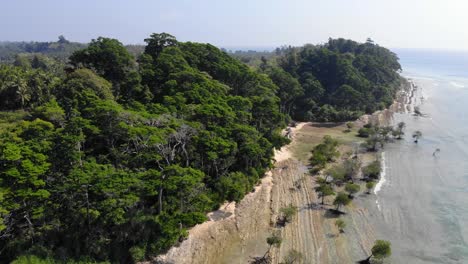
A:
362,80,468,264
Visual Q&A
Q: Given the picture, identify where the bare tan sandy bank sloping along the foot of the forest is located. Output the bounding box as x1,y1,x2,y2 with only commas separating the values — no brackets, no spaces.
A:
152,123,306,264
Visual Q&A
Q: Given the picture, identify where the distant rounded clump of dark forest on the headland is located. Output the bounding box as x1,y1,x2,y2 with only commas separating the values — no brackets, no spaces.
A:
232,39,401,121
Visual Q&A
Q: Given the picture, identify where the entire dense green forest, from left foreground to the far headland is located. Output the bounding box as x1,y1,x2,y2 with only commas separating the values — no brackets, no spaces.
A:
0,33,400,263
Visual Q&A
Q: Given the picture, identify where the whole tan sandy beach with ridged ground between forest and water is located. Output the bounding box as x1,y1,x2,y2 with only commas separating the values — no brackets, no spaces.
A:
154,79,411,264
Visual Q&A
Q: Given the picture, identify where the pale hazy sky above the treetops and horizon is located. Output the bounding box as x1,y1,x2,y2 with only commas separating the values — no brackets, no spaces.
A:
0,0,468,50
